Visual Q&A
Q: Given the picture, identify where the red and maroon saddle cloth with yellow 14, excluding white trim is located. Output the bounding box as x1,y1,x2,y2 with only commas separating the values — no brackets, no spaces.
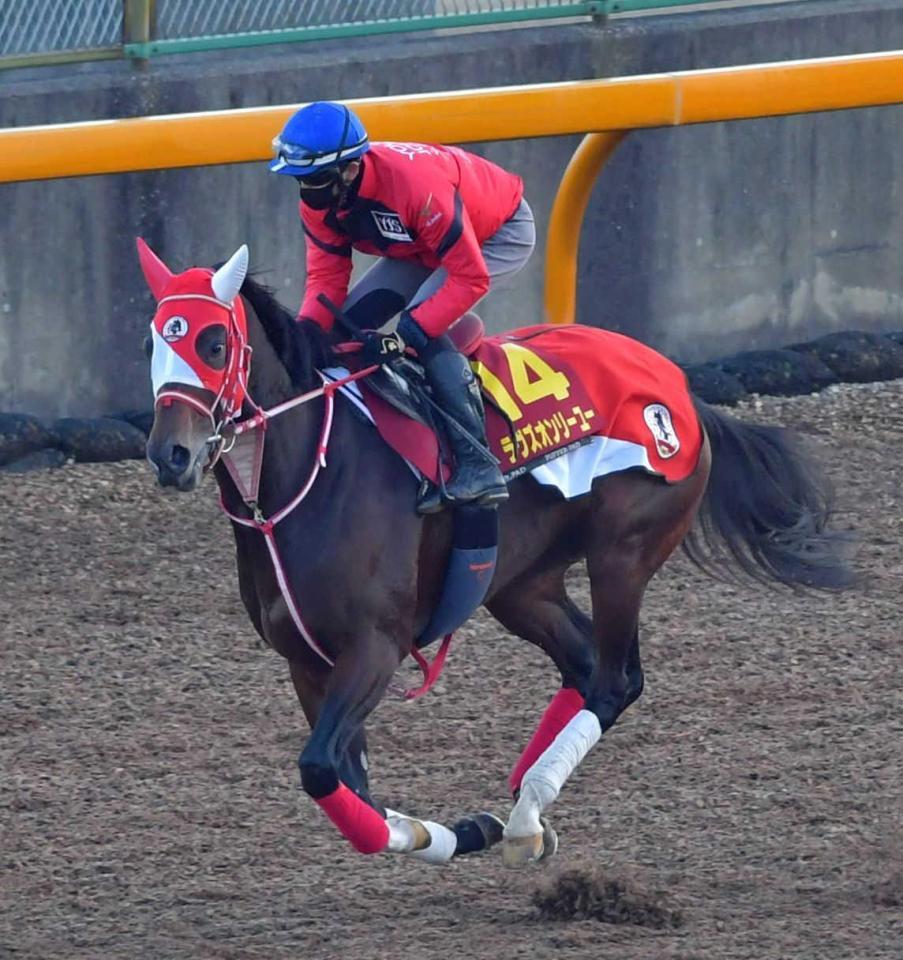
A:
363,317,702,483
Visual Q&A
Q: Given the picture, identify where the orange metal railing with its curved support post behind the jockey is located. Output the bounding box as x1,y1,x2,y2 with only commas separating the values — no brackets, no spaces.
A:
0,51,903,323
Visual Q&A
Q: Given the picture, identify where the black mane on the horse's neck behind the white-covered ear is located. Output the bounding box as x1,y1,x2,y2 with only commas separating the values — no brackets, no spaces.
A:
241,276,336,390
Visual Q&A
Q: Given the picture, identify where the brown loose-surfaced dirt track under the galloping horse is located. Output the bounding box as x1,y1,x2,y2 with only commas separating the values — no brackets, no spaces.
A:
0,381,903,960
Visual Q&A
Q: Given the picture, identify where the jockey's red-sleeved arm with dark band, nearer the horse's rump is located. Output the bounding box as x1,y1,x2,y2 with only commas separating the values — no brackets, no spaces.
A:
410,190,489,337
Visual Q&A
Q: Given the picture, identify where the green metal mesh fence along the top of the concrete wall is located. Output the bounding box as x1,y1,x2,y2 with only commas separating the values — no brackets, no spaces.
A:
0,0,781,67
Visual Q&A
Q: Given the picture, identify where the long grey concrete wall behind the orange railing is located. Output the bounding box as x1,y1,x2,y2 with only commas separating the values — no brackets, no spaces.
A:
0,0,903,415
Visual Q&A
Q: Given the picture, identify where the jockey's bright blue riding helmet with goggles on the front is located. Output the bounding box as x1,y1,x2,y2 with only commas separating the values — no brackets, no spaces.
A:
270,100,370,177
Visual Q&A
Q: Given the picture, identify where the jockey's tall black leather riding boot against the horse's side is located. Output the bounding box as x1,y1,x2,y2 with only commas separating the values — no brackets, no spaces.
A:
420,349,508,512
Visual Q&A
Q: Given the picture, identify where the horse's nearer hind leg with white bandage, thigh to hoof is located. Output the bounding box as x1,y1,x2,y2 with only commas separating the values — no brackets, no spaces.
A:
504,462,707,866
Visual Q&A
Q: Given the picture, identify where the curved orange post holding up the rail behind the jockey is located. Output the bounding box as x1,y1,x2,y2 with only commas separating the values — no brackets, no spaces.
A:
545,130,627,323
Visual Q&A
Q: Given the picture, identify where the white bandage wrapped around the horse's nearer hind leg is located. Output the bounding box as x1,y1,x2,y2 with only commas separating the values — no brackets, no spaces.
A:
505,710,602,837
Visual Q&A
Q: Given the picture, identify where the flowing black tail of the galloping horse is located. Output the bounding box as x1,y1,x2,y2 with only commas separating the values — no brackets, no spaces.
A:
684,397,854,590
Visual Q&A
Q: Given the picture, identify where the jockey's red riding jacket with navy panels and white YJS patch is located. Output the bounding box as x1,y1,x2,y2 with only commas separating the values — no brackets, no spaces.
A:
300,143,524,337
